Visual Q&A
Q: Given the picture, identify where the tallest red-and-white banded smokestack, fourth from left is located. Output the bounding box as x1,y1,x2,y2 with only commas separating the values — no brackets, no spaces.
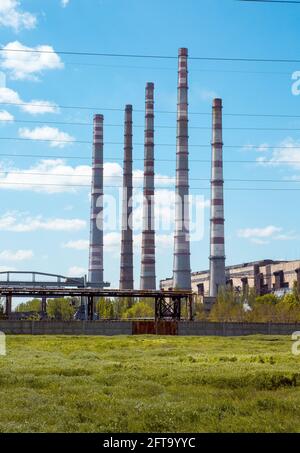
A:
173,48,191,289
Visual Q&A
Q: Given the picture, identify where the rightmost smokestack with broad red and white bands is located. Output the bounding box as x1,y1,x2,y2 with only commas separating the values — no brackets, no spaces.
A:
209,99,226,297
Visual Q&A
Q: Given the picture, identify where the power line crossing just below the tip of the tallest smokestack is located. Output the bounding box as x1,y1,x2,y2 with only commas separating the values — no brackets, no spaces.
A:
0,47,300,63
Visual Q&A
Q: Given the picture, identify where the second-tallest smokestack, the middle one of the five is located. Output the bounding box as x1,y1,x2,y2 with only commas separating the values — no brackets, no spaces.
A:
140,83,156,289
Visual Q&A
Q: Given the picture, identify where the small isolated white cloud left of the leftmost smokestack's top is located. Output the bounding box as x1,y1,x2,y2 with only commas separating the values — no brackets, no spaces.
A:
19,126,74,148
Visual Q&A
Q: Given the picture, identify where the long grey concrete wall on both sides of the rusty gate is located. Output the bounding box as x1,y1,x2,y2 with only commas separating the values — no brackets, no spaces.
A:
0,320,300,336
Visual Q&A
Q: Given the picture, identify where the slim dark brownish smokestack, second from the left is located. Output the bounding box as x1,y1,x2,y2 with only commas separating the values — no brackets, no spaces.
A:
120,105,133,289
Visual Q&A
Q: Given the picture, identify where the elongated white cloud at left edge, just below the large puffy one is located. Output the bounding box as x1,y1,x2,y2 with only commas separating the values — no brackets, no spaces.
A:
0,87,59,115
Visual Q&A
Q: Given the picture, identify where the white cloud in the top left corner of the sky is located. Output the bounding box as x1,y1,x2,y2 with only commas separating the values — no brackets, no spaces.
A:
0,0,37,31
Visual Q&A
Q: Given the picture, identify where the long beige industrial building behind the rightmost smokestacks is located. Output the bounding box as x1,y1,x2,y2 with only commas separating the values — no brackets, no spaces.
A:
160,259,300,296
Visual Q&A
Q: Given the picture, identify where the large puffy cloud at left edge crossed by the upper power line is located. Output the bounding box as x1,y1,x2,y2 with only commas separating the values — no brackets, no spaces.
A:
1,41,64,81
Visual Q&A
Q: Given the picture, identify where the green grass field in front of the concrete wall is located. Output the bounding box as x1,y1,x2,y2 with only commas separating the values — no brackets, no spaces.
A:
0,336,300,432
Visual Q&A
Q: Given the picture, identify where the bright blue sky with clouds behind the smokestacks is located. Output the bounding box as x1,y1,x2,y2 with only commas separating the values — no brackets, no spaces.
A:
0,0,300,286
